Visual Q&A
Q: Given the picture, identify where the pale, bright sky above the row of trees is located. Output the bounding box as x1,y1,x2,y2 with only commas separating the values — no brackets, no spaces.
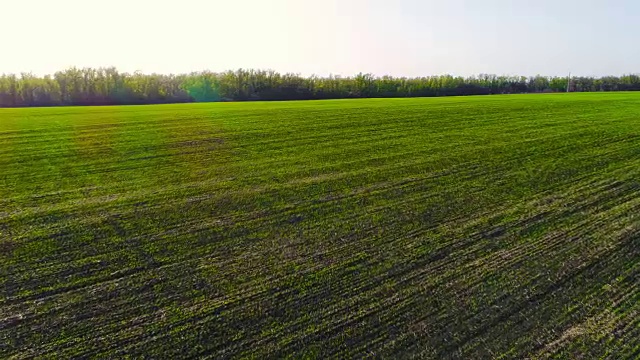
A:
0,0,640,76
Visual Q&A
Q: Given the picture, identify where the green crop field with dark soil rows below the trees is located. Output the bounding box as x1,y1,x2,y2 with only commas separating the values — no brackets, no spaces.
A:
0,93,640,359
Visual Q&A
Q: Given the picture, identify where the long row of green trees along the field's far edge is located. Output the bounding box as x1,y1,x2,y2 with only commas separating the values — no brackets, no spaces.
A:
0,67,640,107
